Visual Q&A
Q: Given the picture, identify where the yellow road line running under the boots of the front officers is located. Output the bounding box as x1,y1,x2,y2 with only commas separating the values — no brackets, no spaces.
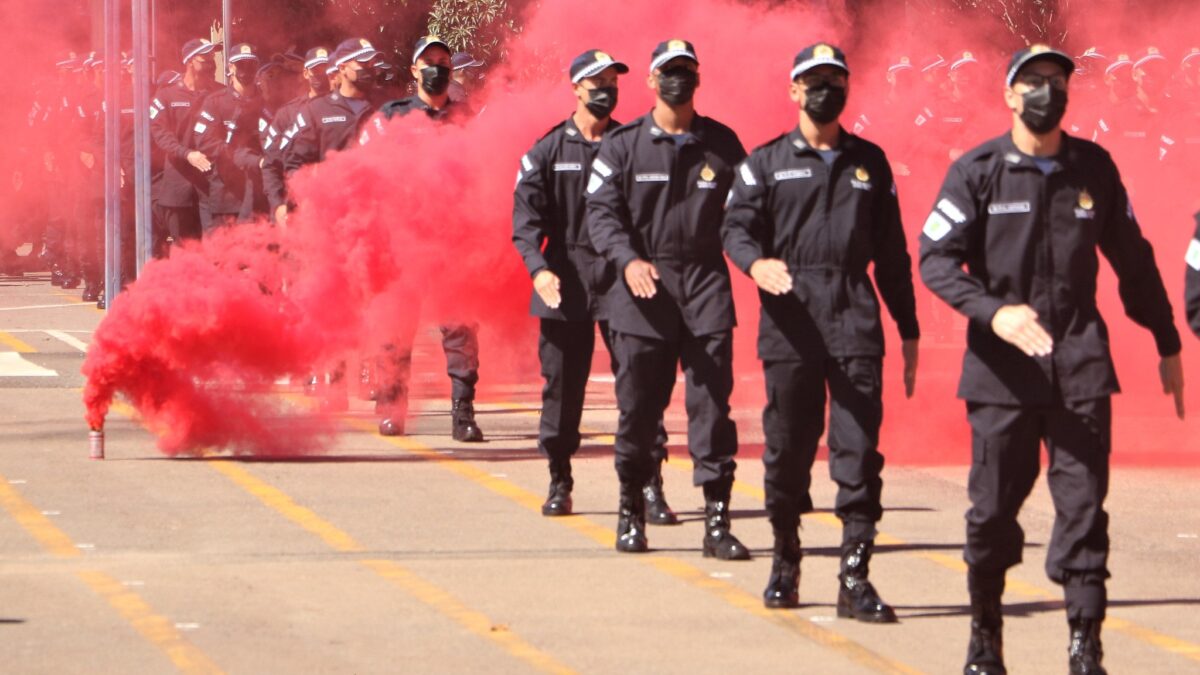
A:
344,419,920,675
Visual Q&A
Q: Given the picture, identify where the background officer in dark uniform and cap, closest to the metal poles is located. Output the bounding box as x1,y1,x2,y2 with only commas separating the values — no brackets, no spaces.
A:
150,40,221,243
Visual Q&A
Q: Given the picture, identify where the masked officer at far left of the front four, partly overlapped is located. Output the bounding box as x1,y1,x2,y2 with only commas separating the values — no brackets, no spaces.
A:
512,49,678,524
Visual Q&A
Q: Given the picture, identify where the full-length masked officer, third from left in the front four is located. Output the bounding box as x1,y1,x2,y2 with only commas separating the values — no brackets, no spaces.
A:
722,43,920,622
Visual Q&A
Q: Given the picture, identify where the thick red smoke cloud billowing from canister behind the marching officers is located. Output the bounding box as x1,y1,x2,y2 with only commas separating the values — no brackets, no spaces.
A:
75,0,1200,462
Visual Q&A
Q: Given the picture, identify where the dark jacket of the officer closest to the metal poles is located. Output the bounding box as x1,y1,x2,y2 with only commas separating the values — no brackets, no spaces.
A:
150,82,216,208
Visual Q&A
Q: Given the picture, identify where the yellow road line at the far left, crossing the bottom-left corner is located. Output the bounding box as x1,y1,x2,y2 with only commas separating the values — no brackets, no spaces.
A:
0,476,221,674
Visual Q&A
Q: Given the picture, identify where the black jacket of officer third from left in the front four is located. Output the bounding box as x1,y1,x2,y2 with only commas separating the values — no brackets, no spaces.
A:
721,129,920,360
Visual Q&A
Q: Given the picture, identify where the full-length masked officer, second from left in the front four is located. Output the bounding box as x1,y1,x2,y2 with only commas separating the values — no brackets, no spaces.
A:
587,40,750,560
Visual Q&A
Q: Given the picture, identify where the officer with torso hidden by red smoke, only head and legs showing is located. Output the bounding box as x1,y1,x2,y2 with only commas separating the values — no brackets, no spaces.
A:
364,35,484,443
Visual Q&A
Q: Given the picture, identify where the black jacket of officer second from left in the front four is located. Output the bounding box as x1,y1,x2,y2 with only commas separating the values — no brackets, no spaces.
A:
587,113,746,340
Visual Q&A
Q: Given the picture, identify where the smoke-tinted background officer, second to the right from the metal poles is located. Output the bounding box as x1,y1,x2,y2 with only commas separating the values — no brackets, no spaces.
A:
192,44,265,232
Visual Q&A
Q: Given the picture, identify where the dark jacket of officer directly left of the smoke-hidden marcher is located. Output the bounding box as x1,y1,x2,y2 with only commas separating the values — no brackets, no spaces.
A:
283,91,376,174
